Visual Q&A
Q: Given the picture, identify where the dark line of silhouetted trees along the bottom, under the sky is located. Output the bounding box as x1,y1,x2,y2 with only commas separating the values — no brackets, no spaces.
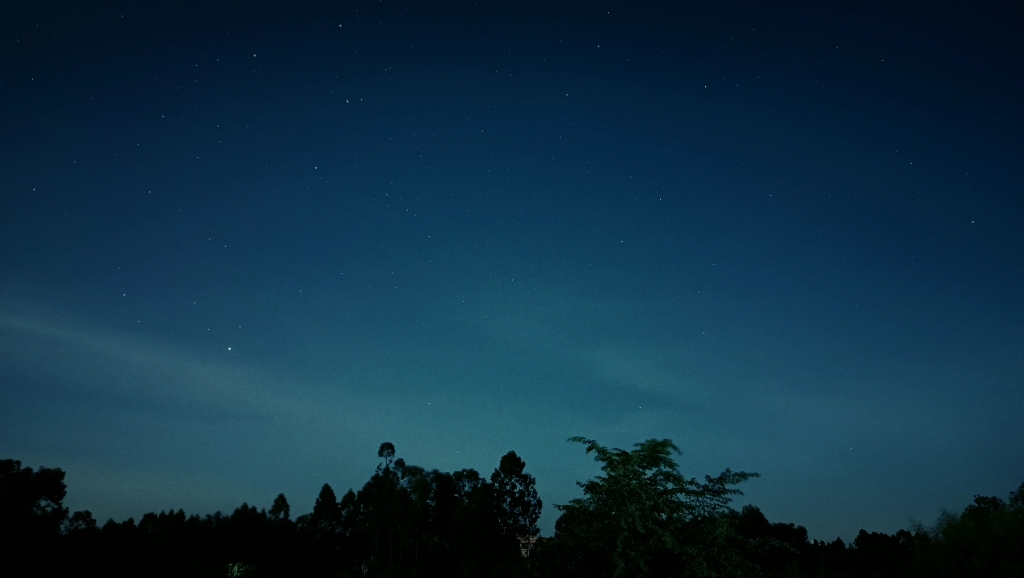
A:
0,438,1024,578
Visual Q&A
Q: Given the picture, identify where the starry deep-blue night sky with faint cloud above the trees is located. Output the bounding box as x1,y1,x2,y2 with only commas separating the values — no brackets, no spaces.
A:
0,0,1024,540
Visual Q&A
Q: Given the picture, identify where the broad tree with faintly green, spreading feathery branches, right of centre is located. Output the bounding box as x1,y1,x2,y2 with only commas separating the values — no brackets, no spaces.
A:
538,437,757,578
